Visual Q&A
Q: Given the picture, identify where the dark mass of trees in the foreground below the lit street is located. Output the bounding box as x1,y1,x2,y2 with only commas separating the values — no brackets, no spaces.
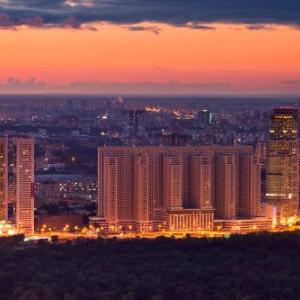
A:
0,232,300,300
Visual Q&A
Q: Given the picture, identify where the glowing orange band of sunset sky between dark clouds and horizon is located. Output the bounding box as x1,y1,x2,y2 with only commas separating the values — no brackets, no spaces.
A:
0,22,300,94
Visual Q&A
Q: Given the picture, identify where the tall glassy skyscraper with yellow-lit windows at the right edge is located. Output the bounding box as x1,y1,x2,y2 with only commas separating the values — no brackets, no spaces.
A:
265,108,299,224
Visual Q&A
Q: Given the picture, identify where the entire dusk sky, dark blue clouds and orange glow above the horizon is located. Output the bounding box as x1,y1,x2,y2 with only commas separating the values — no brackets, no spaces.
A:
0,0,300,94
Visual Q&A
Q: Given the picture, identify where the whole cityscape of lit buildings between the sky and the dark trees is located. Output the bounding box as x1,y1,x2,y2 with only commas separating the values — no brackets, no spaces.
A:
0,96,300,234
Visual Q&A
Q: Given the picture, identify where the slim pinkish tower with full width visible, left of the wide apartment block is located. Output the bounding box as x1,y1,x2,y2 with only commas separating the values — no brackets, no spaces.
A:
14,138,34,234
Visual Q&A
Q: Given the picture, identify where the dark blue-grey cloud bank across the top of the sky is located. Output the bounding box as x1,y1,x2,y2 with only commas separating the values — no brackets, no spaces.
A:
0,0,300,30
